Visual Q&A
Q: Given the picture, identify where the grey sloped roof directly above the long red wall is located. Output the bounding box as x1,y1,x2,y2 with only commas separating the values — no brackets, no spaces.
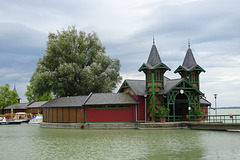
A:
85,93,138,105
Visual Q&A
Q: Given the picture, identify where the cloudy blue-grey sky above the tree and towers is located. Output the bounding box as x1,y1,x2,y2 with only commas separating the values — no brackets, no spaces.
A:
0,0,240,107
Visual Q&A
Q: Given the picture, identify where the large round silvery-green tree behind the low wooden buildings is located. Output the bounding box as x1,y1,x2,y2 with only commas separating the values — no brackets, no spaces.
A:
30,26,122,97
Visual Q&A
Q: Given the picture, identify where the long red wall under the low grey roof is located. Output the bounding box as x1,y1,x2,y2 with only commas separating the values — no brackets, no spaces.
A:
86,106,135,122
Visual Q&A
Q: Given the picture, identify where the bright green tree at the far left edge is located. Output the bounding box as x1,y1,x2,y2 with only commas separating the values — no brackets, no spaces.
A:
0,83,18,108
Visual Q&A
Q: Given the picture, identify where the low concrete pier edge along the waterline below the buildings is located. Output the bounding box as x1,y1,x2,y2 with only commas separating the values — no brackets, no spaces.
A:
40,122,240,131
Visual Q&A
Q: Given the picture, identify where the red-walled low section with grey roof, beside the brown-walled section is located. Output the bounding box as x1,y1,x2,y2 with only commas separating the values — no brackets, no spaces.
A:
84,93,138,122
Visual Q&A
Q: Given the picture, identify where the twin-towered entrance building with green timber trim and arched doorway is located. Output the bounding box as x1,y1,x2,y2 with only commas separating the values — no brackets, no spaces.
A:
119,42,211,121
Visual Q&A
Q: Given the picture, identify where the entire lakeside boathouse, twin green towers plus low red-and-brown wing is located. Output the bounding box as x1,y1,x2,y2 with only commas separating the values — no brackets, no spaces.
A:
42,42,211,123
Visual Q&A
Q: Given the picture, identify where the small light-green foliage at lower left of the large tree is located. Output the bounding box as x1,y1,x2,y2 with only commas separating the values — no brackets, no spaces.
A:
25,83,53,103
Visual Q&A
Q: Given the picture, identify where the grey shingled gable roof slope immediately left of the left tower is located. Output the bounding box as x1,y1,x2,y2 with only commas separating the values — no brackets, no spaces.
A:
126,79,147,96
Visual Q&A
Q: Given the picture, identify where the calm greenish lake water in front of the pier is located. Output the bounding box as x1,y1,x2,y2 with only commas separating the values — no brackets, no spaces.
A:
0,124,240,160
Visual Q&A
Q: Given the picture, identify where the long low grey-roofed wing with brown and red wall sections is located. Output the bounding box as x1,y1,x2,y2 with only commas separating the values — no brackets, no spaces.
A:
42,93,138,123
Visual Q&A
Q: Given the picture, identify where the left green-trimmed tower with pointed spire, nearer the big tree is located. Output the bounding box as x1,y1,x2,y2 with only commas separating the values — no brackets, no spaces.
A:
138,39,171,121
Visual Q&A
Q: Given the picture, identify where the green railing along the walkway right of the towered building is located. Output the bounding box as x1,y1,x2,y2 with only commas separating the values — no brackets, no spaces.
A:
189,115,240,123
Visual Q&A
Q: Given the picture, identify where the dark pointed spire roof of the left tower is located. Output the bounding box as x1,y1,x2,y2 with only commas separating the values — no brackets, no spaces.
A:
147,44,162,68
